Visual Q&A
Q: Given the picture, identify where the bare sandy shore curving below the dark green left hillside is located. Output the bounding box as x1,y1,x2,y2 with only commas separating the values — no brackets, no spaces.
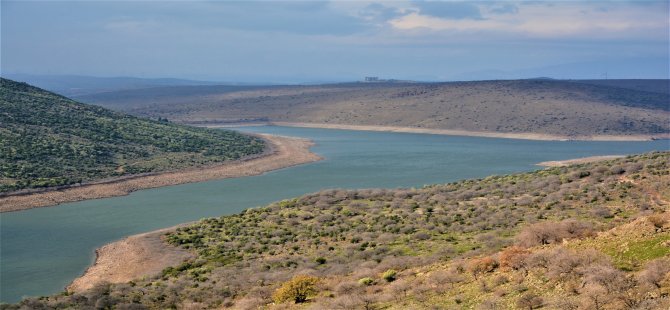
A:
0,135,321,212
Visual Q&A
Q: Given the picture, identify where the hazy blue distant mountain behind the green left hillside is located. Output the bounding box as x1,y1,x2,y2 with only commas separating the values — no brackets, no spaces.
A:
3,74,221,97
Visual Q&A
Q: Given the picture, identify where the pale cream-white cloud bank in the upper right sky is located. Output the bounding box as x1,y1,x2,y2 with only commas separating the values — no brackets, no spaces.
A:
390,2,670,39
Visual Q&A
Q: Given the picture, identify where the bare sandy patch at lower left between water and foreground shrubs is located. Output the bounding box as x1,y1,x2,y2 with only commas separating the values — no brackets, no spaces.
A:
67,227,193,292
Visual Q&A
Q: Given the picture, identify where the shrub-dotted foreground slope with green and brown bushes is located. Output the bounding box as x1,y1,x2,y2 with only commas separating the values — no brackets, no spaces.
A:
6,152,670,309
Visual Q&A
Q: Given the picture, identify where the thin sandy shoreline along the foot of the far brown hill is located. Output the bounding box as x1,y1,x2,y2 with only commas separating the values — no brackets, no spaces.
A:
193,122,670,141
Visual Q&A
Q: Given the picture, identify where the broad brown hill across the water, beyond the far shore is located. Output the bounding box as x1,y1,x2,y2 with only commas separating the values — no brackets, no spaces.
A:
81,80,670,137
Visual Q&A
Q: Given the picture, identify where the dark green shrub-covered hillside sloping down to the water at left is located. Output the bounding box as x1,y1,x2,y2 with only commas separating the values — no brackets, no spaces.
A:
0,79,264,192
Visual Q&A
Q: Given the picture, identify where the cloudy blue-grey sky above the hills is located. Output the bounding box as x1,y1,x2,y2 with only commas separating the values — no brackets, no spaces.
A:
0,0,670,83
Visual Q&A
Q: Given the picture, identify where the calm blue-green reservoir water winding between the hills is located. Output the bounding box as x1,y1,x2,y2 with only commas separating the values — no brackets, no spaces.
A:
0,127,670,302
